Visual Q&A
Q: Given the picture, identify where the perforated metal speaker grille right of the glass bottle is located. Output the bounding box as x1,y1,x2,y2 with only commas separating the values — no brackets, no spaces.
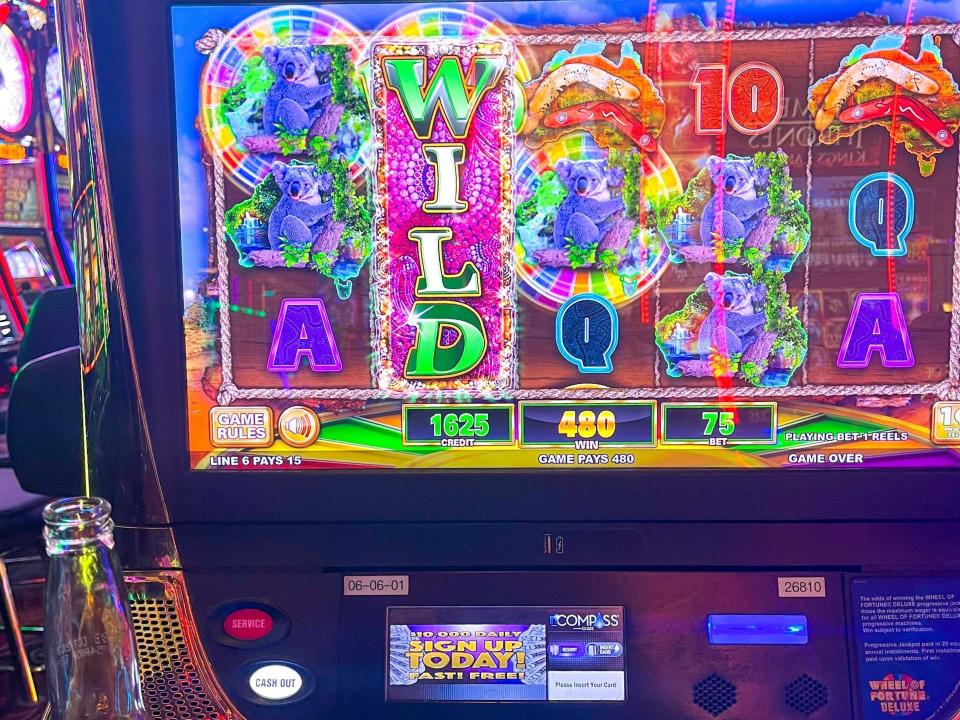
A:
126,574,241,720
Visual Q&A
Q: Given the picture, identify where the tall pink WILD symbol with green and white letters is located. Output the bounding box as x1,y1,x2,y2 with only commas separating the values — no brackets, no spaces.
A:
372,42,513,392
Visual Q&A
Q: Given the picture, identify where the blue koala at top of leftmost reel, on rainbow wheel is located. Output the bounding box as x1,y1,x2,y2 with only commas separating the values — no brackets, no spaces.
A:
263,45,333,133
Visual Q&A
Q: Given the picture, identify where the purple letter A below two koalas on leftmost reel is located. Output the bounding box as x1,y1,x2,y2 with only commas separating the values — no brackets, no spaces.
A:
267,298,343,372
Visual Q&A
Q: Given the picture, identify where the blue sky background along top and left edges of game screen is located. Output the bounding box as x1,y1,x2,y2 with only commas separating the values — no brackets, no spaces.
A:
171,0,960,291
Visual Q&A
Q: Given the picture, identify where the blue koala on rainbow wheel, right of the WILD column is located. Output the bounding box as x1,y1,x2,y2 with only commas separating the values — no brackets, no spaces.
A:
553,159,624,248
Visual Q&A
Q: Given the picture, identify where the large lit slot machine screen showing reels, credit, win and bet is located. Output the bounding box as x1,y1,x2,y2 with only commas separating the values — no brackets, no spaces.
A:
172,0,960,472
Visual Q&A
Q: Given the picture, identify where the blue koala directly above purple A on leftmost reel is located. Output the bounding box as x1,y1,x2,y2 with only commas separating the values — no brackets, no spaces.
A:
267,161,333,250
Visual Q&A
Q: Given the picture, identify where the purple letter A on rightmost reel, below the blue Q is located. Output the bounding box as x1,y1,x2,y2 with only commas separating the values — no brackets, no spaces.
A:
837,293,915,369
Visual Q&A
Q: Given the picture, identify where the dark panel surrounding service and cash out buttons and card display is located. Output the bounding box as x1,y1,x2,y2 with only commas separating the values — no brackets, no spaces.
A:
188,571,852,720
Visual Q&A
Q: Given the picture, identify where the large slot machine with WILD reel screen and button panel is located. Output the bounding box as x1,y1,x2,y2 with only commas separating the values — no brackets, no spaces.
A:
52,0,960,720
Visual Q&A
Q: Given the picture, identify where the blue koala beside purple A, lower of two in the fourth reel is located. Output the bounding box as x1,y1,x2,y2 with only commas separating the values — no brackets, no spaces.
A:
697,273,766,357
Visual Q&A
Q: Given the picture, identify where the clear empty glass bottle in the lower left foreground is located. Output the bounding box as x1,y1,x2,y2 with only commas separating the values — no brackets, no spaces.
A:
43,497,146,720
